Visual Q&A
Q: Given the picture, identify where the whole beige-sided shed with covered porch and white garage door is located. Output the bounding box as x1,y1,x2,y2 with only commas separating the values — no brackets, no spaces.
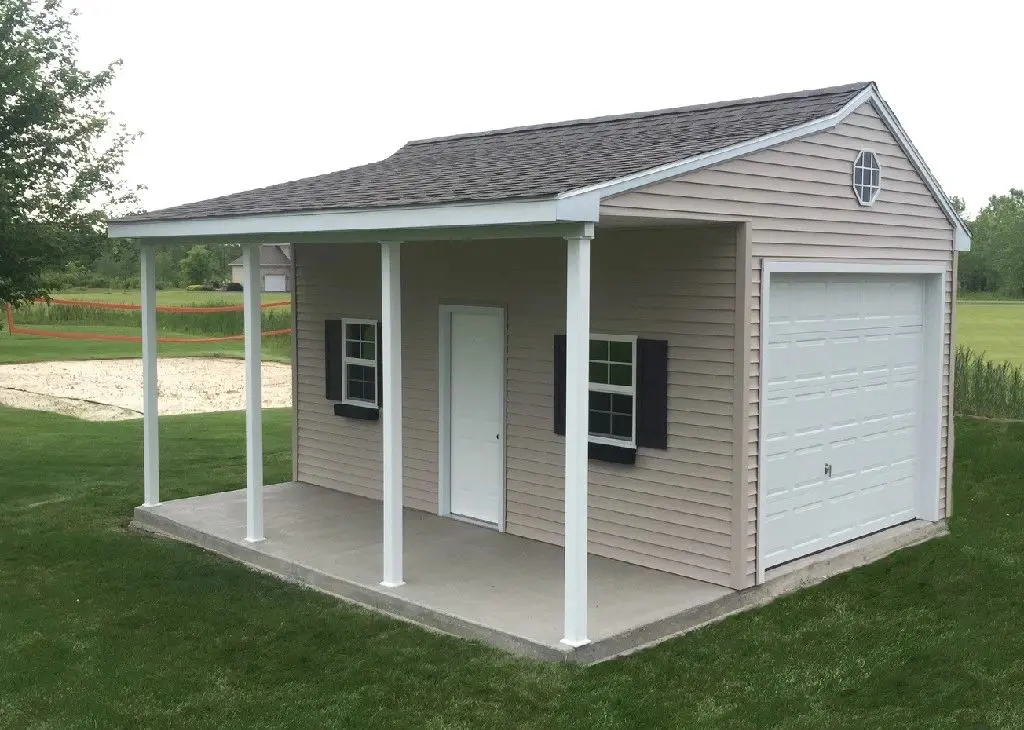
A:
110,83,970,660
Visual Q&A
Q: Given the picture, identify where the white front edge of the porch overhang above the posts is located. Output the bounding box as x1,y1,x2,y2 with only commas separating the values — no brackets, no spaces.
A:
108,194,600,243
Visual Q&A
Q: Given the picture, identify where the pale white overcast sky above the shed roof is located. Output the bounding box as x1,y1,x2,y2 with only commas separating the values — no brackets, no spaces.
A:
68,0,1024,214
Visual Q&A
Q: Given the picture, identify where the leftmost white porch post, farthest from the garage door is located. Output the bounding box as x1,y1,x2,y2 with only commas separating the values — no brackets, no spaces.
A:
139,243,160,507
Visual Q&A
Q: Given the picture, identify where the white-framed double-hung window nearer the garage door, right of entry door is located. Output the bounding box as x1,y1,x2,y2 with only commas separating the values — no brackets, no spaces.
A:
588,335,637,448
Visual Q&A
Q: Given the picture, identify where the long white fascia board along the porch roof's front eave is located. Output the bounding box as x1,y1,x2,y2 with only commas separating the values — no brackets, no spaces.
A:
108,196,600,239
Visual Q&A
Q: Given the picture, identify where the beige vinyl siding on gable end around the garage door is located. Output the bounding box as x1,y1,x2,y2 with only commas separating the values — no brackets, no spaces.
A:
601,103,954,585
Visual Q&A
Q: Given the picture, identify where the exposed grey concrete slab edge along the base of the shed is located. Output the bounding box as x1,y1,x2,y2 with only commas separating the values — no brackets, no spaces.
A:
131,507,948,664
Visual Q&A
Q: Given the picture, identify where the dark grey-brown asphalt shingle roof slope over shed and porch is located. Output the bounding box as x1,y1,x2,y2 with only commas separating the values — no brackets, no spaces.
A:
123,83,869,221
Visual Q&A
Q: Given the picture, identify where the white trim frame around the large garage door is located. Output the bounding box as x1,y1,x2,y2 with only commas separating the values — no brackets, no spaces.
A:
755,259,955,584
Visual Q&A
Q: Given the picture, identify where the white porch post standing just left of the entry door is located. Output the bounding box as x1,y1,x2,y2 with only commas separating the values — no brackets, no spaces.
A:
379,243,404,588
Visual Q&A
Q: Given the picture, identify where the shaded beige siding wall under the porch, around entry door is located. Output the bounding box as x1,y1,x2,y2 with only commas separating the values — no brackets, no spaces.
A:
295,226,736,585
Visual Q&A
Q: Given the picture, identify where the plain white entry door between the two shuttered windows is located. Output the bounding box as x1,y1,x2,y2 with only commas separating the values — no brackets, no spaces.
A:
442,307,505,525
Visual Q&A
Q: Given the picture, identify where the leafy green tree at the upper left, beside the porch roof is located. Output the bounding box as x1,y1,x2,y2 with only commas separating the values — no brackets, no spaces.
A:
0,0,136,304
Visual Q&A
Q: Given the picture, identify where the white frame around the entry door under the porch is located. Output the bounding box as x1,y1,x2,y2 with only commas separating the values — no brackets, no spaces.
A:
437,304,508,532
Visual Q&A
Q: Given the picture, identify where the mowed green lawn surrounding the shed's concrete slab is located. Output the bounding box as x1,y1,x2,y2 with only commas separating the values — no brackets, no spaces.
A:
0,409,1024,730
